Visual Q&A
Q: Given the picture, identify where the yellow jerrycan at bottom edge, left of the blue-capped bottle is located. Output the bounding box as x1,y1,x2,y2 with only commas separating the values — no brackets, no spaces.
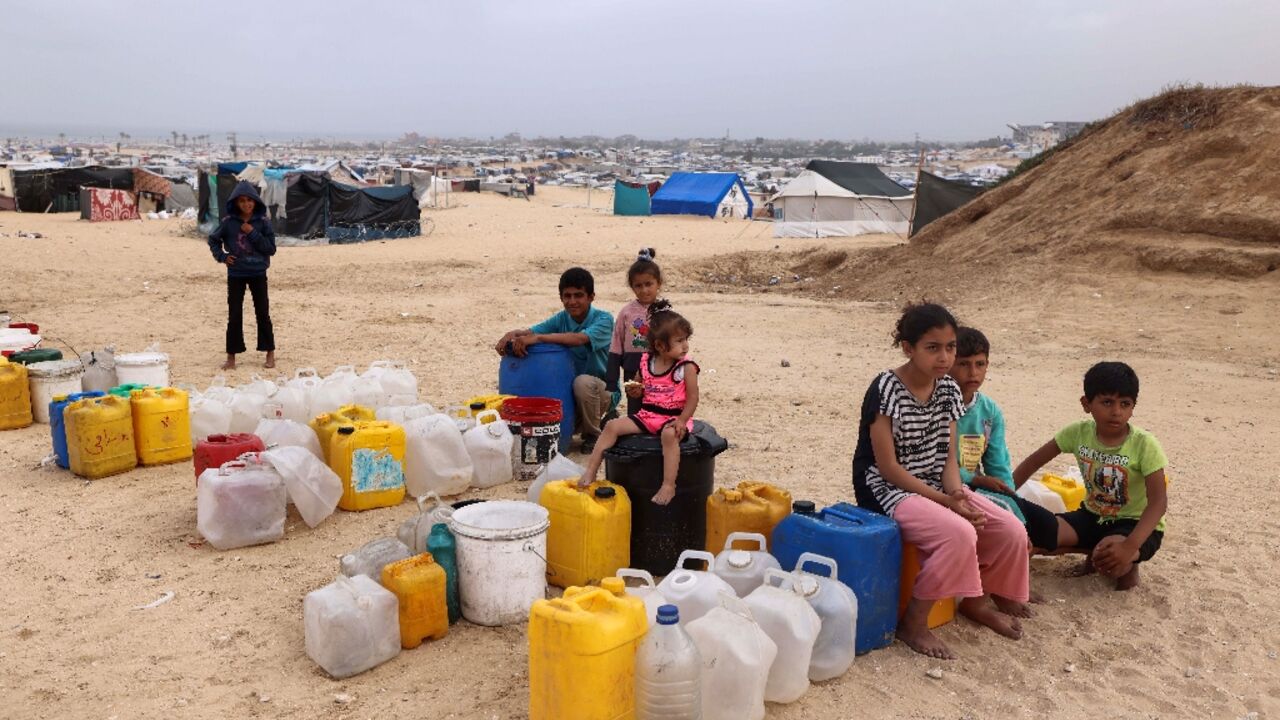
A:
529,578,649,720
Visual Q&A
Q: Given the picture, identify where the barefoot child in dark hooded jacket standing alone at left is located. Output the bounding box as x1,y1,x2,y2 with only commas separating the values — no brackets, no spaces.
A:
209,182,275,370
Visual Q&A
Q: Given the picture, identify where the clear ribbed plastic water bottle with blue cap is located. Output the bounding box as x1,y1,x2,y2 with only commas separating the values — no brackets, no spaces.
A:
636,605,703,720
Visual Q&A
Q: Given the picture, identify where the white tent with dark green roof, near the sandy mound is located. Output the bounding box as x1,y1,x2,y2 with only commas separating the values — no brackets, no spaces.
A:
771,160,911,237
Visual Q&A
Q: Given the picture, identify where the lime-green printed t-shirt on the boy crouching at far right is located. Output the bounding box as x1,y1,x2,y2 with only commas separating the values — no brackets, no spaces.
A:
1053,419,1169,532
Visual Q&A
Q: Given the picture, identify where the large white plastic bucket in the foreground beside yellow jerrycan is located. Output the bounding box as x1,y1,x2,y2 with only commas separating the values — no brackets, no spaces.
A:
449,500,550,625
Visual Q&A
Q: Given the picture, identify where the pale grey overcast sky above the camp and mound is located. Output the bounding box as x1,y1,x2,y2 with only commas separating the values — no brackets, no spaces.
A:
0,0,1280,141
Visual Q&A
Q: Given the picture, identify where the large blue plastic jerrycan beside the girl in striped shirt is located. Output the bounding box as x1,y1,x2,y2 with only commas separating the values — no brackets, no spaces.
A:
773,501,902,655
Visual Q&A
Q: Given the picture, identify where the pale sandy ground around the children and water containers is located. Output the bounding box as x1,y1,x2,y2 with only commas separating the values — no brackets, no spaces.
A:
0,188,1280,720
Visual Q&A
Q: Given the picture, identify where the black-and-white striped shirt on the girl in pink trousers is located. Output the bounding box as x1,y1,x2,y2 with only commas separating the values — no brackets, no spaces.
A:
854,370,964,516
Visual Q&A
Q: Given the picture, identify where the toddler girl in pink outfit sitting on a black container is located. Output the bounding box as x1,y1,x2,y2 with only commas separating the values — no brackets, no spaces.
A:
579,300,698,505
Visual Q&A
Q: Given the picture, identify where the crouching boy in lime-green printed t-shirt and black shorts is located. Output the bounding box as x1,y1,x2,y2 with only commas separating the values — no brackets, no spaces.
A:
1014,363,1169,591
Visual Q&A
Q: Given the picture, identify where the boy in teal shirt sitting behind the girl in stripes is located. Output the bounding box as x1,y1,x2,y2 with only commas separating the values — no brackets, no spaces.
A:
948,328,1057,552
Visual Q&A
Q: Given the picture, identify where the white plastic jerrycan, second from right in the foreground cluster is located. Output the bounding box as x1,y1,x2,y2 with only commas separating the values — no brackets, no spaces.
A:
746,570,822,702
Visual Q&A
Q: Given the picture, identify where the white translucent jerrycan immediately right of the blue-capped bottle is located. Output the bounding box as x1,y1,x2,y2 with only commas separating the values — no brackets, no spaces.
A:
685,593,778,720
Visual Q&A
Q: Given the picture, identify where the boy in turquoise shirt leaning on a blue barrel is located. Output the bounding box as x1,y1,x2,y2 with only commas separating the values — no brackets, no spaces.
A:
497,268,613,452
